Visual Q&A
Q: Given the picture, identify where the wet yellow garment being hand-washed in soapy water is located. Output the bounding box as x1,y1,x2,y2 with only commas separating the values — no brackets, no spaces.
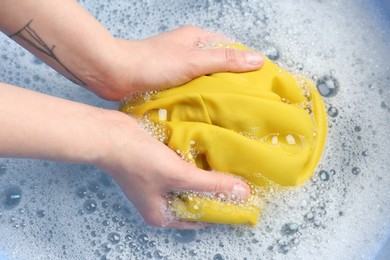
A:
120,46,327,225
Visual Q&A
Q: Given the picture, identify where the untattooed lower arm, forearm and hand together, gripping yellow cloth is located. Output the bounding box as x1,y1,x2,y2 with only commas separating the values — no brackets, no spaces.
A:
0,83,249,228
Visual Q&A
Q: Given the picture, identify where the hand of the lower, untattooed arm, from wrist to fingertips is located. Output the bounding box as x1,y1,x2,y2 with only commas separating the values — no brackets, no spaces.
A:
97,111,249,229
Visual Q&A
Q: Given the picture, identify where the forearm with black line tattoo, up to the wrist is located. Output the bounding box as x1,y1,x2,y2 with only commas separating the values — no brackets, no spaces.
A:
0,0,115,94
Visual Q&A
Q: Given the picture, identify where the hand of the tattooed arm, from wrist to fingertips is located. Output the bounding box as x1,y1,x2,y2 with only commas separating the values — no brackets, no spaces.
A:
95,26,264,100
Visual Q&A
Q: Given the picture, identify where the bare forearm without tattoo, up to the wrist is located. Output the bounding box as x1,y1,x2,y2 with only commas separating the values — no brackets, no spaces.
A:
0,83,116,164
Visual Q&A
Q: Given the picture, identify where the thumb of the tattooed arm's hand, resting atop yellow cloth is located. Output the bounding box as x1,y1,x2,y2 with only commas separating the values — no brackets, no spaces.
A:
189,48,264,77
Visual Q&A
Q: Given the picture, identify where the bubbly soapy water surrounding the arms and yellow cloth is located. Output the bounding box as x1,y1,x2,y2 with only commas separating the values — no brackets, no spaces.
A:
0,0,390,259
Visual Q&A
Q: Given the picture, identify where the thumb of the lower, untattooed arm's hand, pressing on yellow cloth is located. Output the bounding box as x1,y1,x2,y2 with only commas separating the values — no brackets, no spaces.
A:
174,165,250,200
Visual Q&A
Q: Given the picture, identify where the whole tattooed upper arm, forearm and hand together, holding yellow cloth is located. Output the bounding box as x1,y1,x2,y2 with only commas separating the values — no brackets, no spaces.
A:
0,0,263,100
